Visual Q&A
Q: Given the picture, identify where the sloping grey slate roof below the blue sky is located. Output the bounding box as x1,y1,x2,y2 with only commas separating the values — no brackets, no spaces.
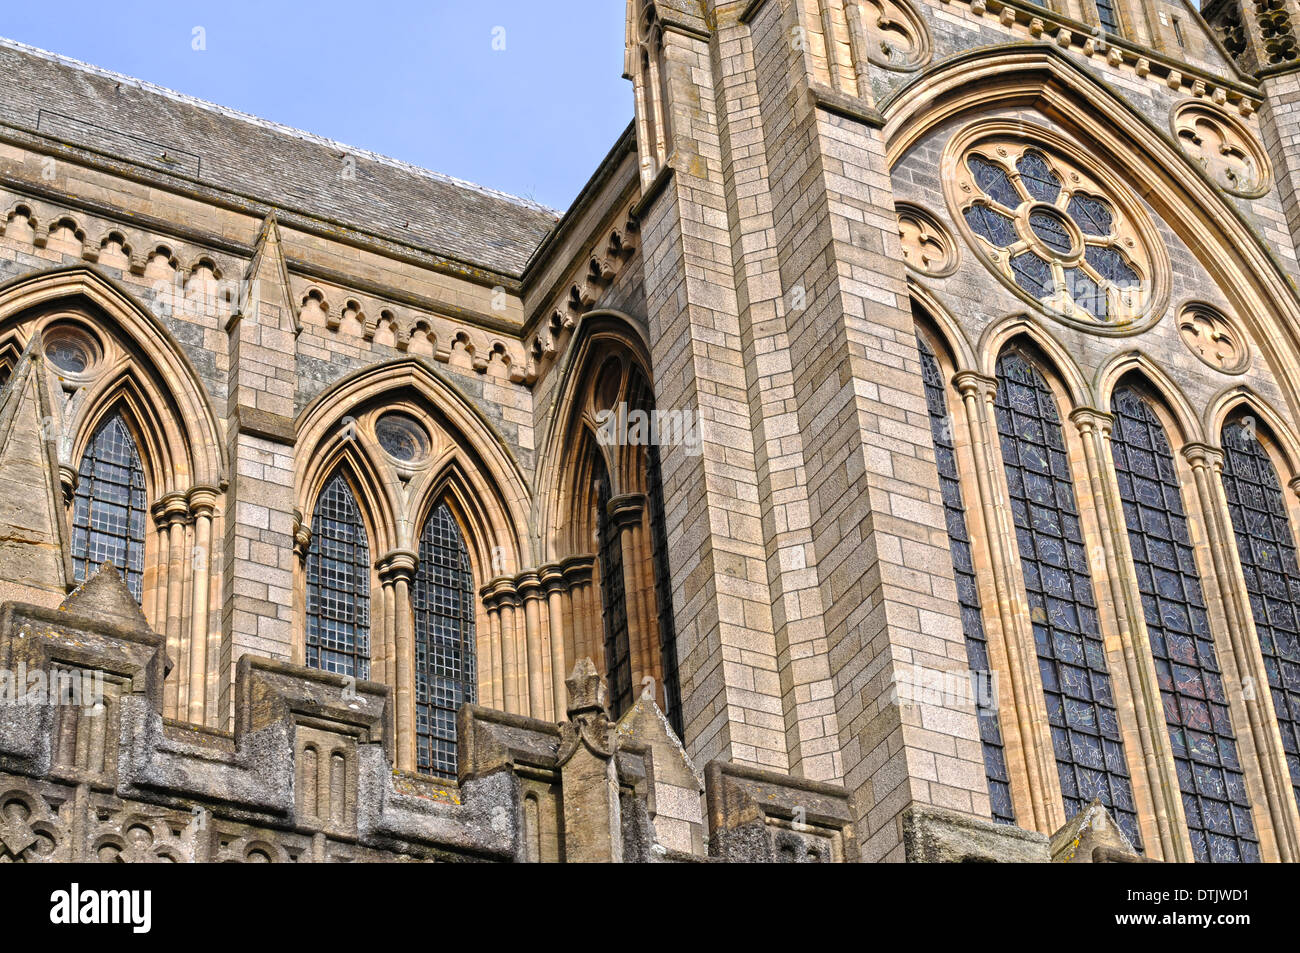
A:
0,38,559,276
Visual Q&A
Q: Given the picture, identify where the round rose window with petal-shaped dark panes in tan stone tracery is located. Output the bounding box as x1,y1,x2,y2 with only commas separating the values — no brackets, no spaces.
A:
957,142,1152,328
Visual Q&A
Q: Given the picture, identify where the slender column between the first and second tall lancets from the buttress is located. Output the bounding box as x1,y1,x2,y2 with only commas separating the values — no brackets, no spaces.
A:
953,371,1065,833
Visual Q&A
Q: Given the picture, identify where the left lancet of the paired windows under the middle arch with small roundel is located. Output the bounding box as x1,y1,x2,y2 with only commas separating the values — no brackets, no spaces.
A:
307,473,371,679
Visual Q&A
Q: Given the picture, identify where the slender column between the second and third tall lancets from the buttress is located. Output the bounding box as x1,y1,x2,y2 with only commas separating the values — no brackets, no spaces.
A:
1070,407,1192,861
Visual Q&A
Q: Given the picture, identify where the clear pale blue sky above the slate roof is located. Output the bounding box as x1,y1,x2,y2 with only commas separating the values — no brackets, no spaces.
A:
0,0,632,209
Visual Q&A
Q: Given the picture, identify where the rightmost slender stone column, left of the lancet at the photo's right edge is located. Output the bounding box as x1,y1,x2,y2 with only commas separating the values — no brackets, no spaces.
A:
1183,443,1300,862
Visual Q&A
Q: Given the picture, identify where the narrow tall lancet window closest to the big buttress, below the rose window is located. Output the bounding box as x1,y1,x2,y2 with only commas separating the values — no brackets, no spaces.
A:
917,335,1015,824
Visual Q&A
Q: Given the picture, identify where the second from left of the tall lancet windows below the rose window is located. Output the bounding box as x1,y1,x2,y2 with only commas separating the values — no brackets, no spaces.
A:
996,350,1140,846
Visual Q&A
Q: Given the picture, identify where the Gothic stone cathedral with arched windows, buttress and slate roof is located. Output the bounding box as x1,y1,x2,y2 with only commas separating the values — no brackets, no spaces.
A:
0,0,1300,863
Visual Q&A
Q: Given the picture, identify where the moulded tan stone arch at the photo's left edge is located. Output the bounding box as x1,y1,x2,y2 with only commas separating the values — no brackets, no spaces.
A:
0,265,225,499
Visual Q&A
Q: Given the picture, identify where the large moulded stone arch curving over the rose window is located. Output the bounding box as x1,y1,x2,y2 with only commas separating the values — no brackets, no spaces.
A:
880,46,1300,442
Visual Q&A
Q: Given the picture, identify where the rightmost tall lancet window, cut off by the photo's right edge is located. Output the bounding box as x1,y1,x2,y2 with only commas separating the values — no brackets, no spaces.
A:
1223,417,1300,802
